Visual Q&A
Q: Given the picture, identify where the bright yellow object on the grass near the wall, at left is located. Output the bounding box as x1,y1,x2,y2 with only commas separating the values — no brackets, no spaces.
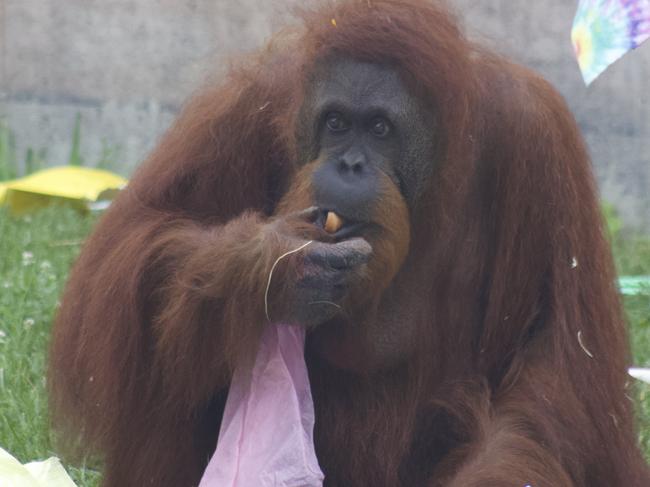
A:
0,166,127,213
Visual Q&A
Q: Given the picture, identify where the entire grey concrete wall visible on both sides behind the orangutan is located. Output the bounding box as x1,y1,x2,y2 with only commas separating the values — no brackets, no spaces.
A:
0,0,650,230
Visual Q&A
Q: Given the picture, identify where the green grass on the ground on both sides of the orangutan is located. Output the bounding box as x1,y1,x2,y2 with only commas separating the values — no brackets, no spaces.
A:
0,208,650,487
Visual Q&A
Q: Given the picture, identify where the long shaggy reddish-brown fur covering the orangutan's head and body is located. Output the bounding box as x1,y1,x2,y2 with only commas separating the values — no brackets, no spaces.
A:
48,0,650,487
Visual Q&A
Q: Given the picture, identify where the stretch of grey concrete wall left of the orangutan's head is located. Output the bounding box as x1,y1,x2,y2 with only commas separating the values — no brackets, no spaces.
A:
0,0,286,172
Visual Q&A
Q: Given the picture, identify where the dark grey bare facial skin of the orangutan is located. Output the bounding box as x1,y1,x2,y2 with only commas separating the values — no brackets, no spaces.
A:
302,60,433,215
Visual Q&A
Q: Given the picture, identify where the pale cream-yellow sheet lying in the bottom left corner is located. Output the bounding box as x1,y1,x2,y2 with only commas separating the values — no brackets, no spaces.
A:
0,448,76,487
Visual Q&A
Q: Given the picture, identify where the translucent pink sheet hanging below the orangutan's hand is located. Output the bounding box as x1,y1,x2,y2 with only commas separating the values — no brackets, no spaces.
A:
199,325,323,487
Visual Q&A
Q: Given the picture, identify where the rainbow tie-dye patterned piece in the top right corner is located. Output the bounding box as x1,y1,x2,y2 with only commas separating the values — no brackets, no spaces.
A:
571,0,650,85
